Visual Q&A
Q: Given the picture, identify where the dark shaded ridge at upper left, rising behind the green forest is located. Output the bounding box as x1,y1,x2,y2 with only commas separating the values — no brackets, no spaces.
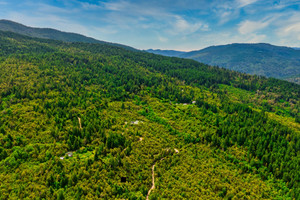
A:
0,19,136,50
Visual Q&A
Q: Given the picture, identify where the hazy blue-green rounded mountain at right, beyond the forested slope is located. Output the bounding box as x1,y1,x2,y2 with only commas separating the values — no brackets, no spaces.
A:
149,43,300,81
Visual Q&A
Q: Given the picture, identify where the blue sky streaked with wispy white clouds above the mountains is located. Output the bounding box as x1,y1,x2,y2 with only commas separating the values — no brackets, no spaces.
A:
0,0,300,51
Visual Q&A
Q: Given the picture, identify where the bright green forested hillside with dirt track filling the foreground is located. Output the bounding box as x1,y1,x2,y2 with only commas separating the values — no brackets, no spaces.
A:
0,32,300,199
